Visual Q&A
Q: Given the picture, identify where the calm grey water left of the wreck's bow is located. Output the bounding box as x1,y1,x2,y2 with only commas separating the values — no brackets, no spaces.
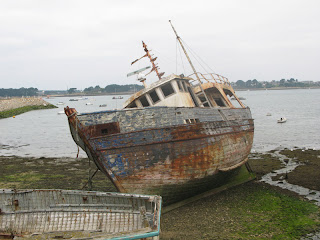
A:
0,96,129,157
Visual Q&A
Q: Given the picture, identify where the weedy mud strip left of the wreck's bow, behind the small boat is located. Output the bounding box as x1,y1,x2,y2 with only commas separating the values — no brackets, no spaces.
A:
0,156,116,192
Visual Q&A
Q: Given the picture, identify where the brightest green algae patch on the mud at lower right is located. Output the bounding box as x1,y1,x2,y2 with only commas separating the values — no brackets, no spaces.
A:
230,185,320,239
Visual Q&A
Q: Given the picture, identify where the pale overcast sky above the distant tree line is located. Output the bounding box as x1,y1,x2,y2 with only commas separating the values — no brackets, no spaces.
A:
0,0,320,90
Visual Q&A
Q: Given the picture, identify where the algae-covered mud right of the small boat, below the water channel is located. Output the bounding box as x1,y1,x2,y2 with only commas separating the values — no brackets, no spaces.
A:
161,182,320,239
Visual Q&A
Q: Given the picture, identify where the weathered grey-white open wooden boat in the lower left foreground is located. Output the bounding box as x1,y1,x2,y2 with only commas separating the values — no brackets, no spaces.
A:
0,189,161,239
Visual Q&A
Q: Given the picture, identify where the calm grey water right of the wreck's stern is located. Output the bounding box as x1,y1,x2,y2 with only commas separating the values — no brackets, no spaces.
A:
237,89,320,152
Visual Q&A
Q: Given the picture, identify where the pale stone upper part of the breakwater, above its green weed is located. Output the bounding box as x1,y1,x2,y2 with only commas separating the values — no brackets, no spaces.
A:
0,97,49,112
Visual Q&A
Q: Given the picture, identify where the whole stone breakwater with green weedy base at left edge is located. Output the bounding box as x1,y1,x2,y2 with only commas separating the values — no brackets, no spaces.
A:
0,97,56,118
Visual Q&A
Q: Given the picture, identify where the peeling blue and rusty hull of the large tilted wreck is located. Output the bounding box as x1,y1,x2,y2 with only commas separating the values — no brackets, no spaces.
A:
65,107,254,205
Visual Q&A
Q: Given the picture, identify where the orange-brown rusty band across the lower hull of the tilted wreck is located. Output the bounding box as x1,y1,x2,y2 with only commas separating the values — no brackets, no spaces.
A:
121,132,253,183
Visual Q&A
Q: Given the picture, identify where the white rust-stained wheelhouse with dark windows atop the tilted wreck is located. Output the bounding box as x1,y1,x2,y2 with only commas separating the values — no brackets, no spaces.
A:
124,74,245,108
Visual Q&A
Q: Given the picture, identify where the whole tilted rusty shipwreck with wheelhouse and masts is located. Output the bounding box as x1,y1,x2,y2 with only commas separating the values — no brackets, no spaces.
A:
65,21,254,204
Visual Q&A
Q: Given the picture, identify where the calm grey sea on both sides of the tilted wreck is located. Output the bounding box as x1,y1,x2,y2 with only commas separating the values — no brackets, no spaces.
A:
0,89,320,157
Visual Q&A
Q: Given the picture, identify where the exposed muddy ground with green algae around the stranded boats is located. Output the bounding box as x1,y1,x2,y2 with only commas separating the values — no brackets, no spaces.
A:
0,149,320,239
